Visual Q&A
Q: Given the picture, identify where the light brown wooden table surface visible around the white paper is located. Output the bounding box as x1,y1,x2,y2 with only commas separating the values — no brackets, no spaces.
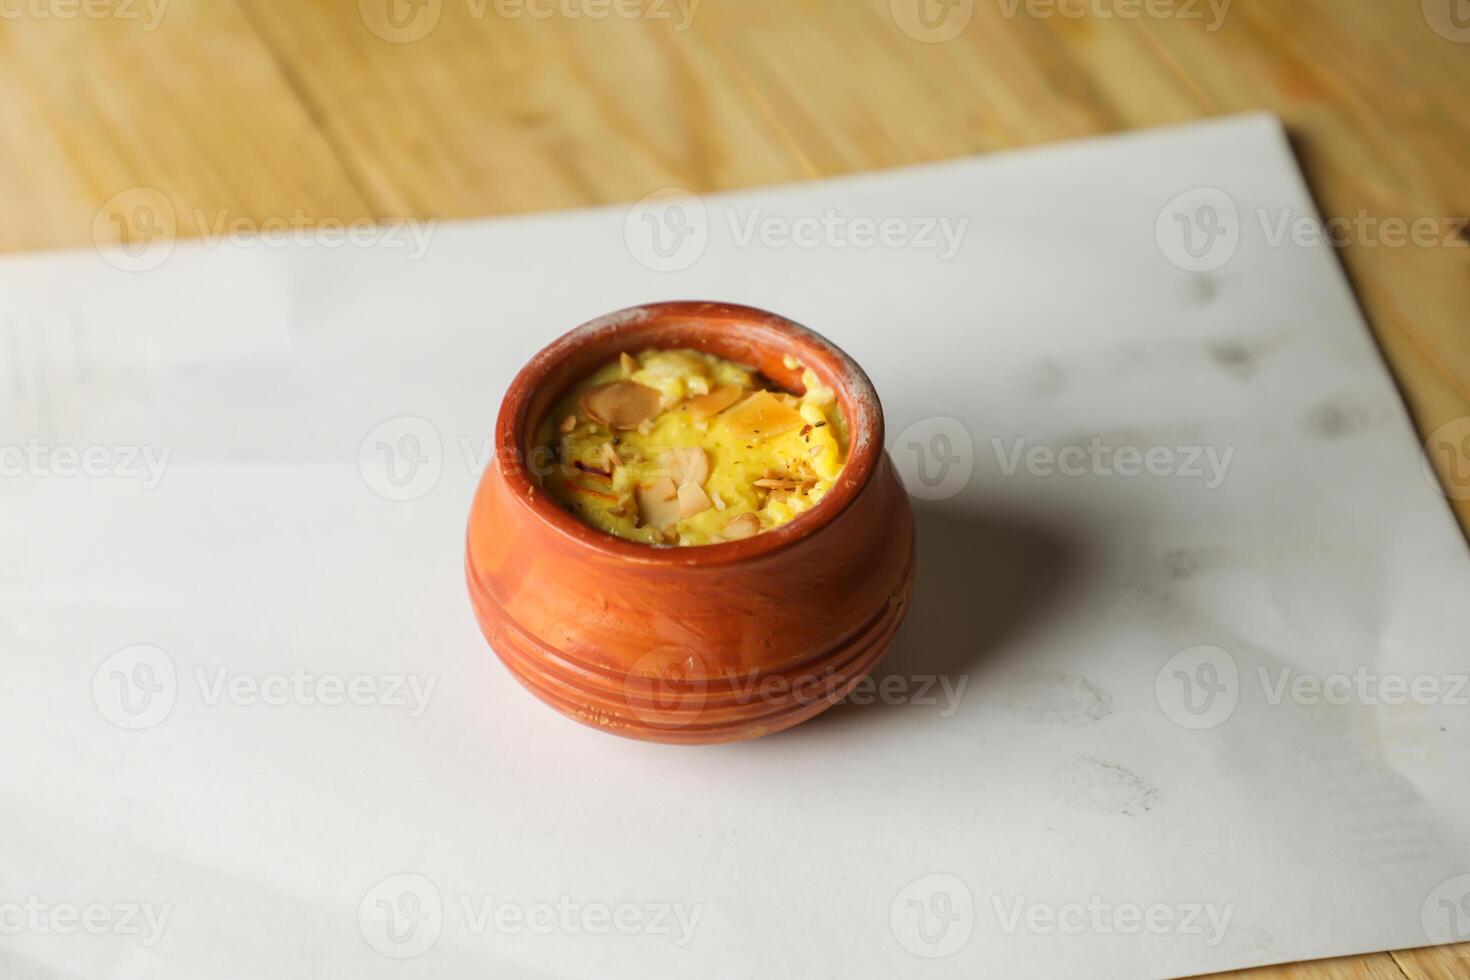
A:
0,0,1470,980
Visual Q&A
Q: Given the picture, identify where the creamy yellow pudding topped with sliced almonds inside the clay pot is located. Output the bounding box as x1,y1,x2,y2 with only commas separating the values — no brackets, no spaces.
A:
531,350,847,545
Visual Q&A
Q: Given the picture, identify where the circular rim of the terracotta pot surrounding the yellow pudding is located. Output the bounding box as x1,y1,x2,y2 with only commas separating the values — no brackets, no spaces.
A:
492,300,883,567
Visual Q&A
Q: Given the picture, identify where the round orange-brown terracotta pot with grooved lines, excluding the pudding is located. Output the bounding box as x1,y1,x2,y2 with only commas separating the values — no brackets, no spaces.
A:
466,303,914,743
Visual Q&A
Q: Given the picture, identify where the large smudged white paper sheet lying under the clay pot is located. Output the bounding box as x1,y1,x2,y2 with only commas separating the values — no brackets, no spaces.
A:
0,116,1470,980
